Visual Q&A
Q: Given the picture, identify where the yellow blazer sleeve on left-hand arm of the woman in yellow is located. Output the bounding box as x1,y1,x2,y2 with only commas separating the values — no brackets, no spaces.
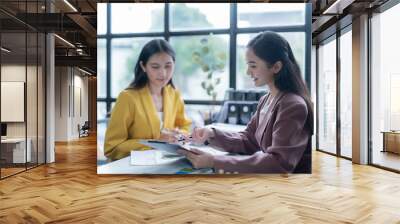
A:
104,92,150,160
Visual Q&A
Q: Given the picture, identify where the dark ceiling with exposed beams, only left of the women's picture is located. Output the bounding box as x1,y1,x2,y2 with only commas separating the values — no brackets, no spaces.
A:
0,0,97,74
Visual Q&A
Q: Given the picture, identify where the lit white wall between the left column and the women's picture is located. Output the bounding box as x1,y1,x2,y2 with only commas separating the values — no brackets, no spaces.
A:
55,67,88,141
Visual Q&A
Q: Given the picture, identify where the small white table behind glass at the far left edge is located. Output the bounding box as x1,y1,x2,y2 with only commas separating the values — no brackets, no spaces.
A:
1,138,32,163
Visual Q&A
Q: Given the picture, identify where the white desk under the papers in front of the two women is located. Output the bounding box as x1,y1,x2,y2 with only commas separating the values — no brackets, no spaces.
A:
97,123,246,174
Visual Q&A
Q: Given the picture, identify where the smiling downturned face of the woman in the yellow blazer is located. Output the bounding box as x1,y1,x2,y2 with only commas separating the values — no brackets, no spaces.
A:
140,52,175,88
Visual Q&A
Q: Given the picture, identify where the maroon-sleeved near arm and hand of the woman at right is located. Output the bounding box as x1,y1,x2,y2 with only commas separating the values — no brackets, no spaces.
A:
214,102,310,173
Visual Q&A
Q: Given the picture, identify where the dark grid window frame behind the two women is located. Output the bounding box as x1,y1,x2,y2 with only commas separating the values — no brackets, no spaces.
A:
97,3,312,122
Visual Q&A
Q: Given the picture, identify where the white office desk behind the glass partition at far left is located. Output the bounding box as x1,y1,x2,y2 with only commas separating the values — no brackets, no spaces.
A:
1,138,32,163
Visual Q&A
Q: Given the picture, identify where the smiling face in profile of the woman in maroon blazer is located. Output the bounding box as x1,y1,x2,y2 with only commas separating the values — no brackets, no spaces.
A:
246,48,282,87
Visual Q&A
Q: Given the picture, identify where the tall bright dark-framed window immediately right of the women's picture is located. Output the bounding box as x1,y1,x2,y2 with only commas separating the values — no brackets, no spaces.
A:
316,24,353,159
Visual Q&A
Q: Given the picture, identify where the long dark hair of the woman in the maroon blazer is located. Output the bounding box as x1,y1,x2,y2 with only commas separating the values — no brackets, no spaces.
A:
247,31,314,133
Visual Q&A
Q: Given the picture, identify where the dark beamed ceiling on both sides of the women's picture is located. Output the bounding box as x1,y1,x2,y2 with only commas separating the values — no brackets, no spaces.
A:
0,0,387,73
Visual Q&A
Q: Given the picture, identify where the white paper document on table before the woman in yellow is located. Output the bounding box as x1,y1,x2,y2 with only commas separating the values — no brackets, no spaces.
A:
131,150,184,166
